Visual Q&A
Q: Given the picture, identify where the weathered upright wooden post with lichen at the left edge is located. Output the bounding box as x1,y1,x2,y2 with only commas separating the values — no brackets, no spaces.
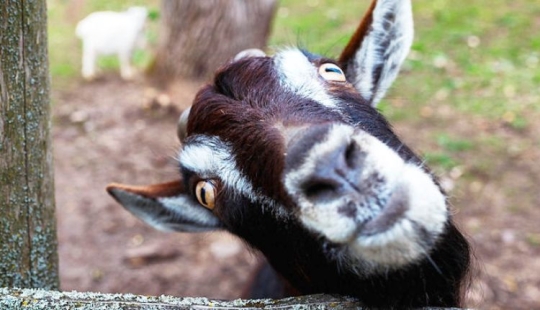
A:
0,0,58,289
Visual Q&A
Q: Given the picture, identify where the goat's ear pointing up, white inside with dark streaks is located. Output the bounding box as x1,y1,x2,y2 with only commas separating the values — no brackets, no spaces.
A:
339,0,414,106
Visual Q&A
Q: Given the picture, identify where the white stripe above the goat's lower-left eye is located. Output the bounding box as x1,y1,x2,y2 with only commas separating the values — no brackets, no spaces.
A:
179,135,288,216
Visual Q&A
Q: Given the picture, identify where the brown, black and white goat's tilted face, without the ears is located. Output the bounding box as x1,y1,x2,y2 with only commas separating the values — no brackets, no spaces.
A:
174,49,448,271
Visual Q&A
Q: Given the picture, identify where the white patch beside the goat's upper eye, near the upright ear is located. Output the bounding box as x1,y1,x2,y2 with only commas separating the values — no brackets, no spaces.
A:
274,49,338,109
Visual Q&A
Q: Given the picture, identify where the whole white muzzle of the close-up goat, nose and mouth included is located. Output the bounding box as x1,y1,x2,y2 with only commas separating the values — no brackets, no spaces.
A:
285,126,448,268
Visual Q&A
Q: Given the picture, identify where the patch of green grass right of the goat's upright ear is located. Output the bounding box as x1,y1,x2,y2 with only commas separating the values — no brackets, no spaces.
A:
396,0,540,120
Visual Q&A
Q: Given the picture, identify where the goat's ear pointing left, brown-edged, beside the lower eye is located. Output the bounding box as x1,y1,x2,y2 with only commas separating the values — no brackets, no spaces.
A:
107,181,221,232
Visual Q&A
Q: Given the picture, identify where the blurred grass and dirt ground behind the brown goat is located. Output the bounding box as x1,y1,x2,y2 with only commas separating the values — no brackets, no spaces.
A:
47,0,540,309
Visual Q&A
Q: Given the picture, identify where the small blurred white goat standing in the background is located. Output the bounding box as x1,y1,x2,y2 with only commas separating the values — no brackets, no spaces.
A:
75,7,148,80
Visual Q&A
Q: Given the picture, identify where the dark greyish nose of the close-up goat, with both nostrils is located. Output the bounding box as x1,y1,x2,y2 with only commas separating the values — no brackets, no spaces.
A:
286,125,365,206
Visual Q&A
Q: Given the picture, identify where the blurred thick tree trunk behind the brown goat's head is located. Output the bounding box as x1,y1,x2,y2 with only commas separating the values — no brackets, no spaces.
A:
149,0,276,81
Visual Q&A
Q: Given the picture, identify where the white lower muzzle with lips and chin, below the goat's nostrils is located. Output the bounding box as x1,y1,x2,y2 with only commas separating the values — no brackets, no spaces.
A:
299,168,448,269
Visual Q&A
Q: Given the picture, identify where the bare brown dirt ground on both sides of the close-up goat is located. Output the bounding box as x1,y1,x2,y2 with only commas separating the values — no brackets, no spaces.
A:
53,74,540,309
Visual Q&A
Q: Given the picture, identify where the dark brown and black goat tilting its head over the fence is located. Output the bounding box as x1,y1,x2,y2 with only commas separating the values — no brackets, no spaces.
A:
107,0,470,309
